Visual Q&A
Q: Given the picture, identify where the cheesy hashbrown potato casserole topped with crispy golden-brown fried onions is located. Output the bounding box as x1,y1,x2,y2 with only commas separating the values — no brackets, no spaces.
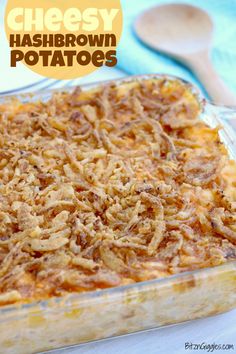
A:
0,79,236,305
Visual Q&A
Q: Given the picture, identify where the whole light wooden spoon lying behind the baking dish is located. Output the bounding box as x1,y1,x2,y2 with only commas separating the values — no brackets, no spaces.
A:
135,4,236,106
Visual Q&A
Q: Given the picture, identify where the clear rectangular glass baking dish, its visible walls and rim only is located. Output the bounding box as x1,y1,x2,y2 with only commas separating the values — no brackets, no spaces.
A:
0,75,236,354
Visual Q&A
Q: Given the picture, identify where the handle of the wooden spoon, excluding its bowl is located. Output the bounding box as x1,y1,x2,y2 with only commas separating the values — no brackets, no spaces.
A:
186,52,236,106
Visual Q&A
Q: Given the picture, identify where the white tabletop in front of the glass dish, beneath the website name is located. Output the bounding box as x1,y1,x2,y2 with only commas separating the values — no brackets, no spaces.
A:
53,310,236,354
